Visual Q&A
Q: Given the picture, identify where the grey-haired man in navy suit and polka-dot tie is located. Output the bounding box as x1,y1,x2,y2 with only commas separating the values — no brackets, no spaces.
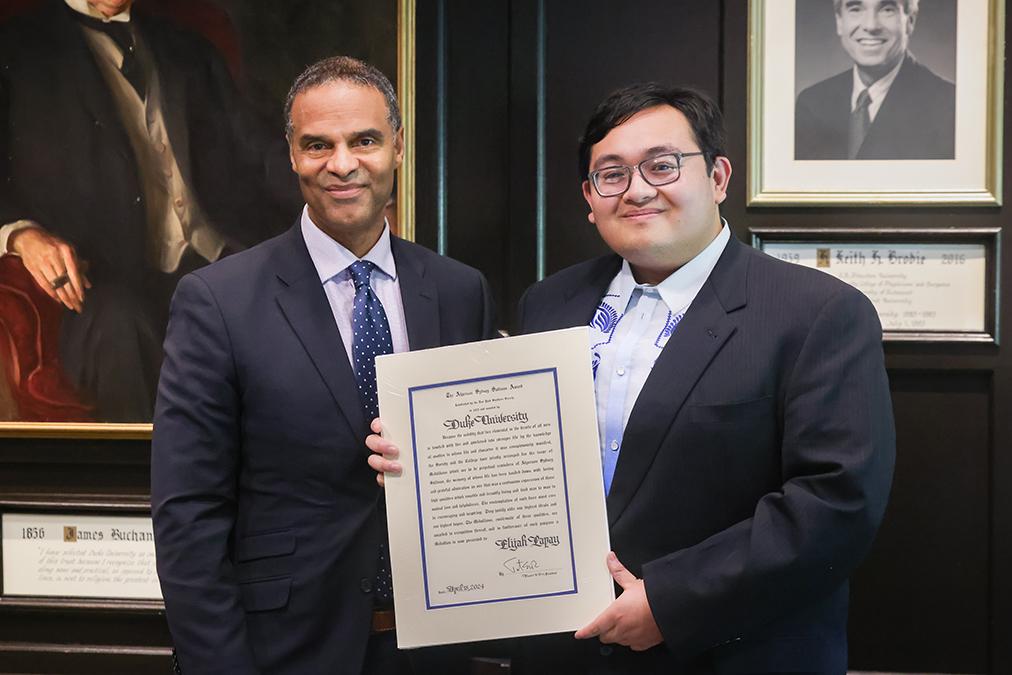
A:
152,57,494,675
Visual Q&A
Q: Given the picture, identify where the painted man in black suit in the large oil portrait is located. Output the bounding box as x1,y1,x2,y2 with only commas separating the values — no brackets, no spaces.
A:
0,0,298,422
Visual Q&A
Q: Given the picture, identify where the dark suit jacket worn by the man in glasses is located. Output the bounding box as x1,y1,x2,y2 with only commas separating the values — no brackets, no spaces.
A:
520,237,895,673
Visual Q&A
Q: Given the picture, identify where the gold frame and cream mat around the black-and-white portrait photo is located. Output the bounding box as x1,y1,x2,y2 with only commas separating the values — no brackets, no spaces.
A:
747,0,1005,206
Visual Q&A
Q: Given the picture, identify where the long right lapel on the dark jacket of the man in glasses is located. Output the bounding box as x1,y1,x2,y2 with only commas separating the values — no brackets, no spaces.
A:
607,235,748,525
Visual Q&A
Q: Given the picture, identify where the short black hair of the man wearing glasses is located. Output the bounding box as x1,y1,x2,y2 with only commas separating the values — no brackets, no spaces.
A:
580,82,727,180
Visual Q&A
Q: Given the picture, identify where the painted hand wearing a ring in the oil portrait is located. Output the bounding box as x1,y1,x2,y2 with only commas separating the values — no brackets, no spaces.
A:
7,228,91,314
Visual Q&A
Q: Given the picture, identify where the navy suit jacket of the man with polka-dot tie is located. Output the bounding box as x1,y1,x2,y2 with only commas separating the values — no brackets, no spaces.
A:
151,224,494,675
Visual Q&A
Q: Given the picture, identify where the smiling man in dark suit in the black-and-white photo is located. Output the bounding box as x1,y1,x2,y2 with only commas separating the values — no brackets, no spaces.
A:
794,0,955,160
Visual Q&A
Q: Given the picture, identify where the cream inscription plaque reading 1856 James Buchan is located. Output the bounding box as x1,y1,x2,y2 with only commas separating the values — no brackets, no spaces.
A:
2,513,162,600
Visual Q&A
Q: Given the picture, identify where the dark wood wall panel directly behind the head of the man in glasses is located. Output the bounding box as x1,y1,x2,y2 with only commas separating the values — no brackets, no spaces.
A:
544,0,722,273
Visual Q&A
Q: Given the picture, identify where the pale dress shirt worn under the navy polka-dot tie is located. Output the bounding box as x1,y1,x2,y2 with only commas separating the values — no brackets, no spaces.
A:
302,206,410,363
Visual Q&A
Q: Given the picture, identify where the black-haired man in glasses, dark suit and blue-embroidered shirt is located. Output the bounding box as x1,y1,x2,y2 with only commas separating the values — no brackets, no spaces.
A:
368,84,895,675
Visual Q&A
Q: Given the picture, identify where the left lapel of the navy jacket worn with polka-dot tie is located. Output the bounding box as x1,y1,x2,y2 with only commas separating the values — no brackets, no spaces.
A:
275,226,368,438
